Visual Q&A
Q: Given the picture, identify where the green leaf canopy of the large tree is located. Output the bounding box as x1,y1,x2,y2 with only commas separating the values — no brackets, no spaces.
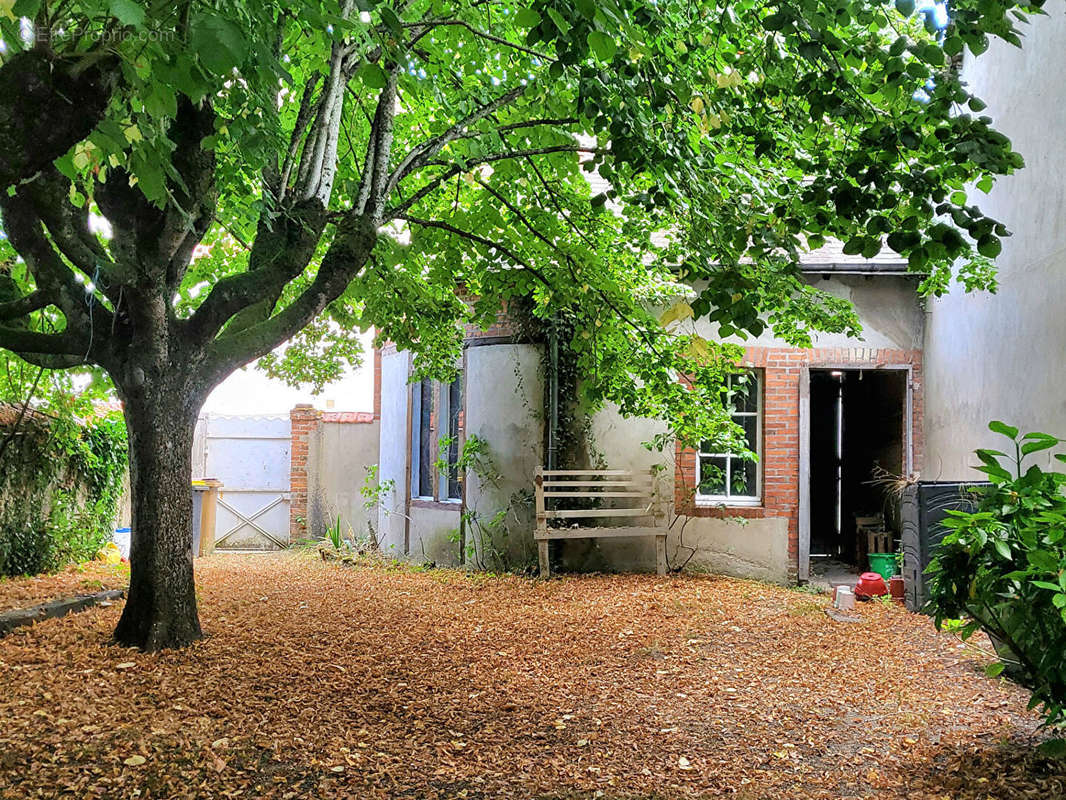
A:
0,0,1043,462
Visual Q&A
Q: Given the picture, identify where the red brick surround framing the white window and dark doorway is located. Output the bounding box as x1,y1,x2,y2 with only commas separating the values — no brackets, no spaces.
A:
674,347,924,579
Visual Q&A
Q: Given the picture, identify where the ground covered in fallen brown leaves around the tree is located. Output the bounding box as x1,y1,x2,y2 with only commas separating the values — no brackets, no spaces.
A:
0,554,1066,799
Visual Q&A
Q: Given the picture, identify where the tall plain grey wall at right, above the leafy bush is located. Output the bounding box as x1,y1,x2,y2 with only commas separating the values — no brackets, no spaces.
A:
922,9,1066,480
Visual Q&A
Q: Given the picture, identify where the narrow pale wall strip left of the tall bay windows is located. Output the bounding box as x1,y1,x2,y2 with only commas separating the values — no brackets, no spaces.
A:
377,352,410,556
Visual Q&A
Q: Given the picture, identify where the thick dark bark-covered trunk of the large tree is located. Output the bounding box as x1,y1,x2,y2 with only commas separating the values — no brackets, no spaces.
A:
115,382,203,651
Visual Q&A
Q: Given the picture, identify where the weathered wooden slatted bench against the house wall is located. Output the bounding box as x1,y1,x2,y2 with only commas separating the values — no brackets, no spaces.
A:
533,466,666,578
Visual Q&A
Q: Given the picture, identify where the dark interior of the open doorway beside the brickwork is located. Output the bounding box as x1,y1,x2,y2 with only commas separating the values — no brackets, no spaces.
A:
810,369,907,566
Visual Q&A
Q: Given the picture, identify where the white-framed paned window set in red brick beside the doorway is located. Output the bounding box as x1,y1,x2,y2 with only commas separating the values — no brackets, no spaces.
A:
696,372,762,502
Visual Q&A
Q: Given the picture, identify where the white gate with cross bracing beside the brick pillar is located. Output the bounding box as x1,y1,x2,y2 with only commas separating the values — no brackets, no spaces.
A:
193,414,292,550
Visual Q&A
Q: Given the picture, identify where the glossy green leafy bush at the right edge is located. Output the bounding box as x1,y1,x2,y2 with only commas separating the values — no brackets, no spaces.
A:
927,422,1066,724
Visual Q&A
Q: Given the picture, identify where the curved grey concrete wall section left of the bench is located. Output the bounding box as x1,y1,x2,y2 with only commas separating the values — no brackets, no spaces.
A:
466,345,544,569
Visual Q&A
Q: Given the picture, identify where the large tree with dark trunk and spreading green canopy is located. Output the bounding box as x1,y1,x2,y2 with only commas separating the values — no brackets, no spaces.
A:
0,0,1040,649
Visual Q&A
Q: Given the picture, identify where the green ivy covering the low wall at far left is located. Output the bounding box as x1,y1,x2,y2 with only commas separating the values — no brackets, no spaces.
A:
0,414,128,575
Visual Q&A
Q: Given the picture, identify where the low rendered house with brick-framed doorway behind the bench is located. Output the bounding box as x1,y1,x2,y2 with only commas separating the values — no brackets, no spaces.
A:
377,246,924,582
